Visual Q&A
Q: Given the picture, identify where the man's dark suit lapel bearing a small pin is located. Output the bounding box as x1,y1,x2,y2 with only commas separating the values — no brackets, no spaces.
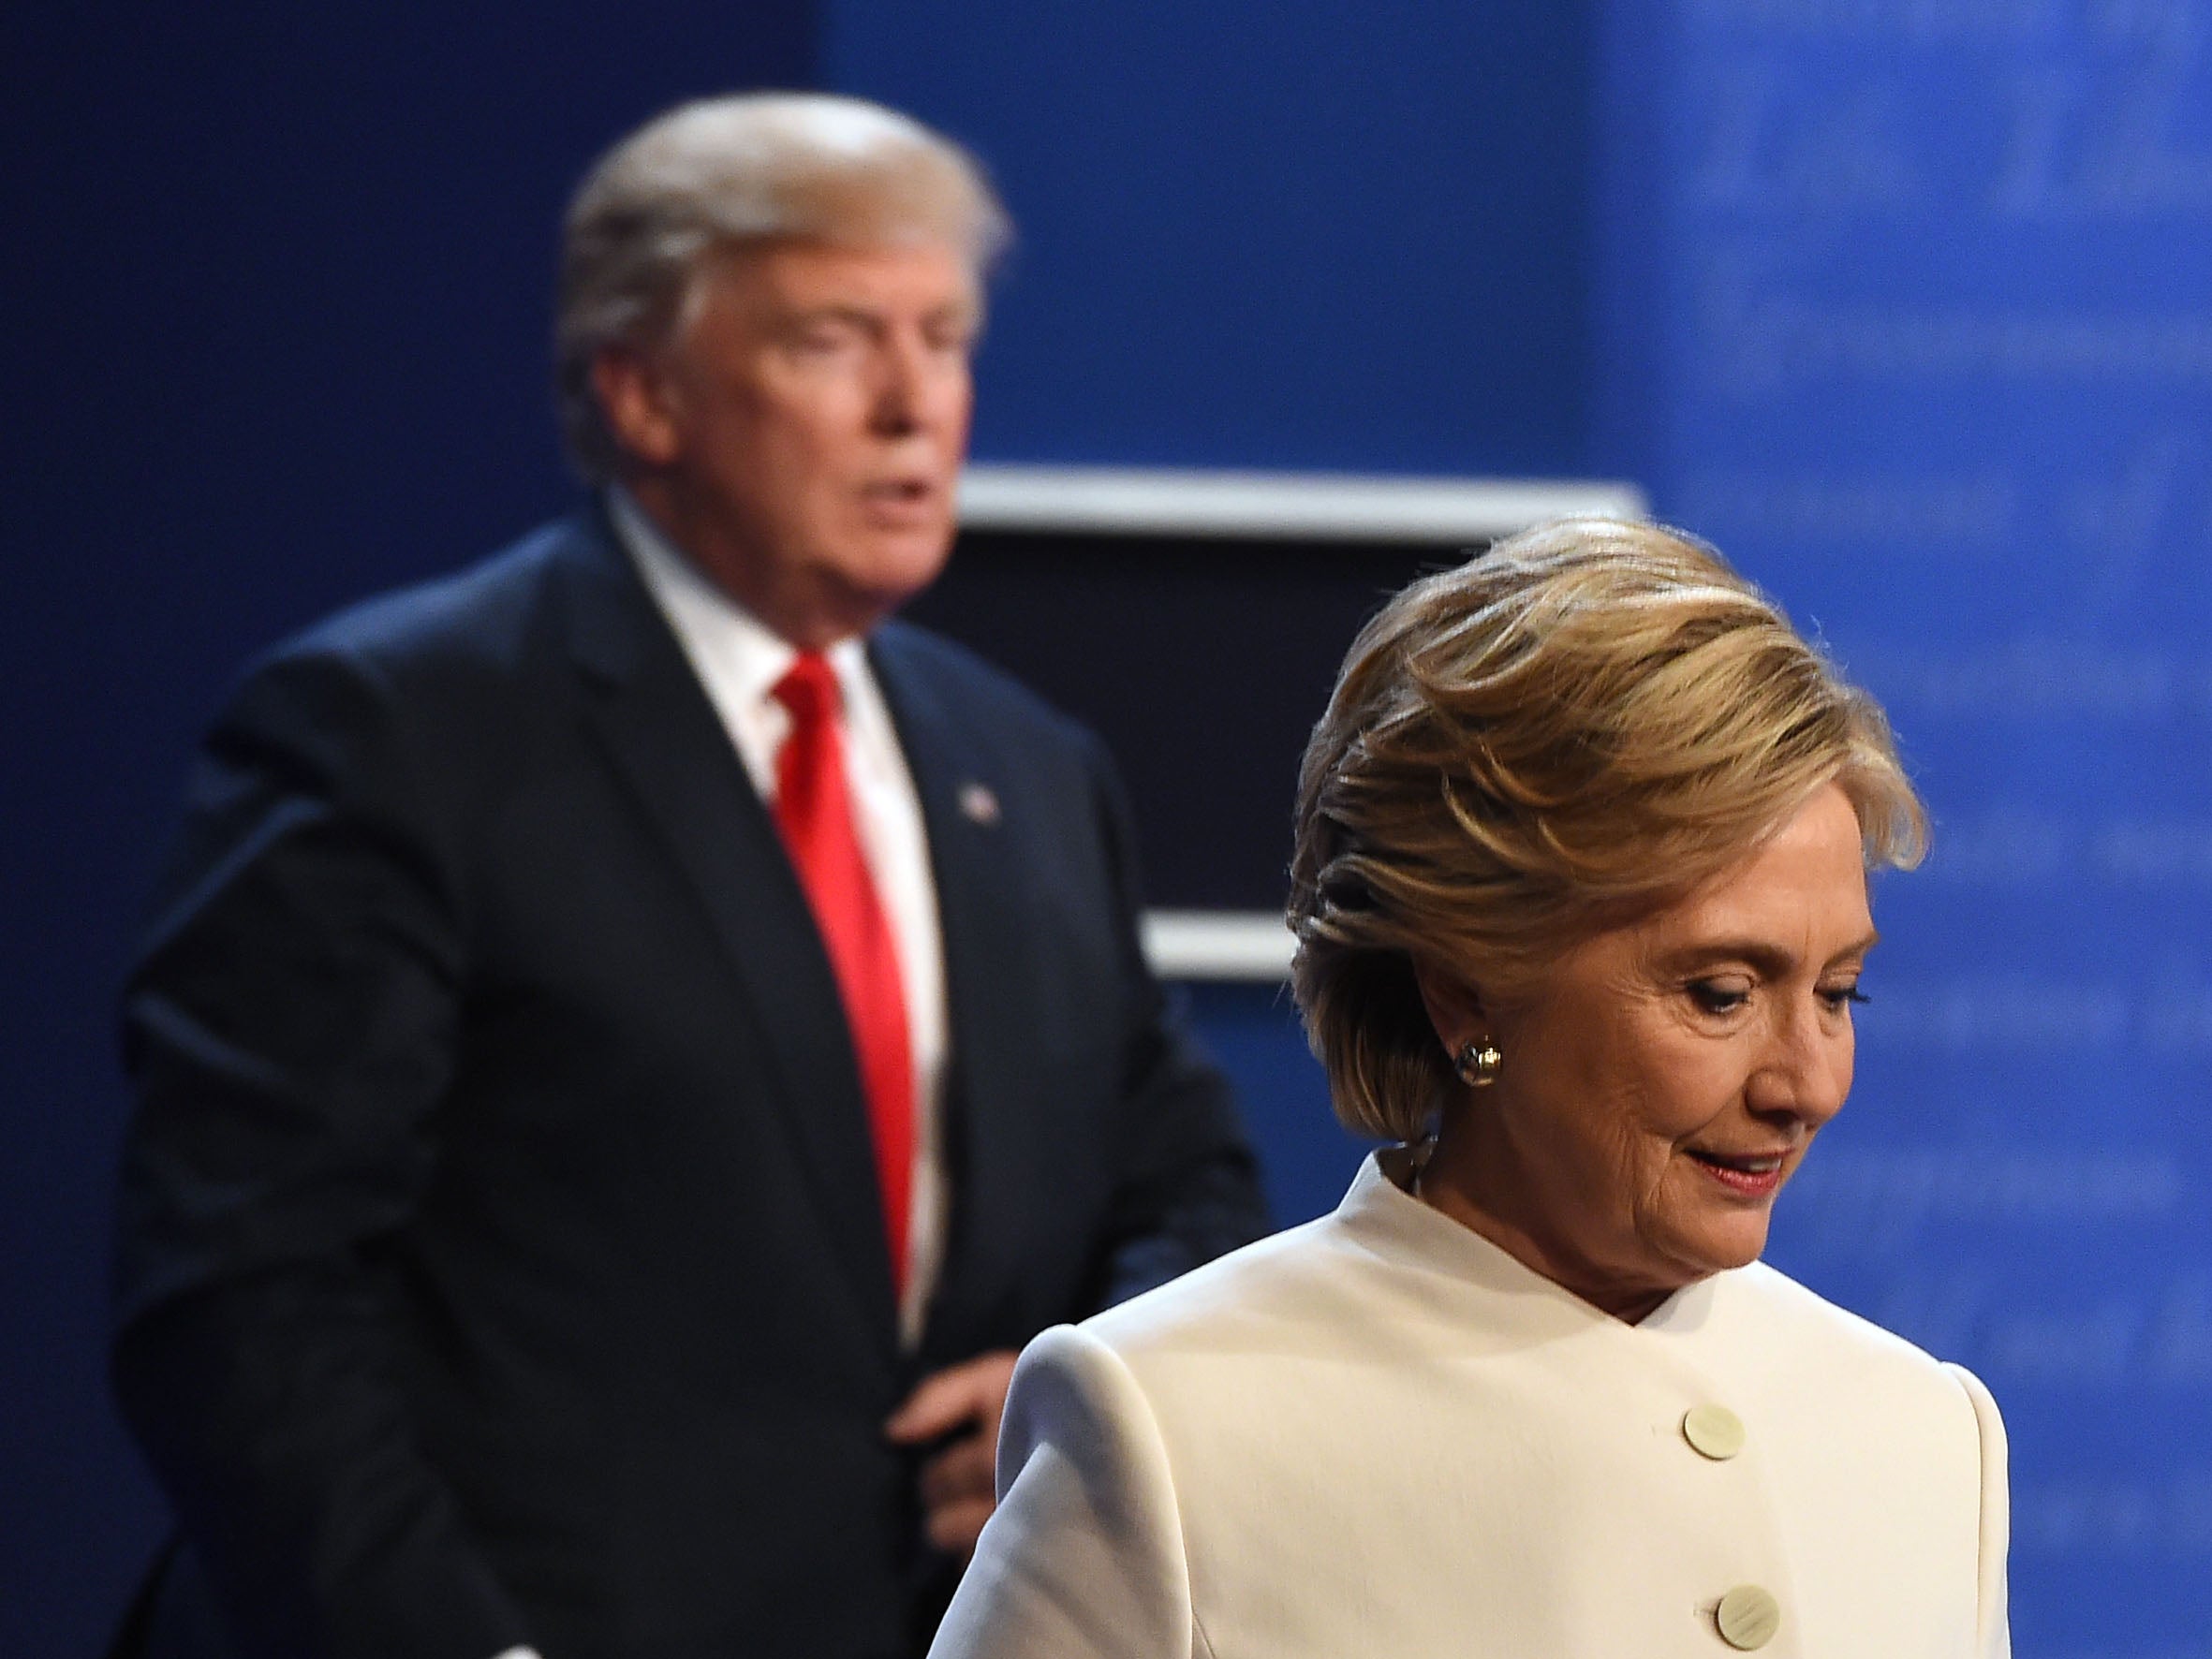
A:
869,624,1051,1347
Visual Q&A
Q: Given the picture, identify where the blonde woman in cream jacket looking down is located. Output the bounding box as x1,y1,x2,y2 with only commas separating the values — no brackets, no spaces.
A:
934,520,2009,1659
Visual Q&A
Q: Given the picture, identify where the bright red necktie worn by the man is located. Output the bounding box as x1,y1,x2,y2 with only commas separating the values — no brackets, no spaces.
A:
774,651,914,1297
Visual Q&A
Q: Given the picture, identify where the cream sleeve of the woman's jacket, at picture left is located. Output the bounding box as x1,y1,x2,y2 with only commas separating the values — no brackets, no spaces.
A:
929,1325,1210,1659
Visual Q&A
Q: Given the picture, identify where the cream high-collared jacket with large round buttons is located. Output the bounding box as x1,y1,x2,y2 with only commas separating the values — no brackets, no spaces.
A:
931,1152,2011,1659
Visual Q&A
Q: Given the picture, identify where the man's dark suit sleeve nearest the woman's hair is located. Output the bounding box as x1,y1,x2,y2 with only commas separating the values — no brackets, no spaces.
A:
1090,739,1270,1307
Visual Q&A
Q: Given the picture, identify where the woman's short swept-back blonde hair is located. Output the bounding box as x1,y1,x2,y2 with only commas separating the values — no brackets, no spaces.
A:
1290,518,1926,1139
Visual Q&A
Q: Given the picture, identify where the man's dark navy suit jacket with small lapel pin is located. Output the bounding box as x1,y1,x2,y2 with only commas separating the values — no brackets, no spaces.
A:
115,513,1263,1659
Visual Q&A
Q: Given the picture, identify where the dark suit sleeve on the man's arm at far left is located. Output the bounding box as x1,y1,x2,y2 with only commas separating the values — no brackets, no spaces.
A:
112,648,531,1659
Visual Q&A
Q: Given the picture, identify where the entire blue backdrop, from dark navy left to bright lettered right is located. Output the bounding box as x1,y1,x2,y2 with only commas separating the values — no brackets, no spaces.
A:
0,0,2212,1659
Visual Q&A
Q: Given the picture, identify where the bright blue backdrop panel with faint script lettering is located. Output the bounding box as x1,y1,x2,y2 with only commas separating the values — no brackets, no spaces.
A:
1597,0,2212,1659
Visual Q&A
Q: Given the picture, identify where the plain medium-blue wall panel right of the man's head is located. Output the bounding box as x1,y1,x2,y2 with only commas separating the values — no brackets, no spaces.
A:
823,0,1595,474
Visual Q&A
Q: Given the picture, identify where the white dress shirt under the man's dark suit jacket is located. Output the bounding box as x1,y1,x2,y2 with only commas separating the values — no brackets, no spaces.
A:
609,489,951,1352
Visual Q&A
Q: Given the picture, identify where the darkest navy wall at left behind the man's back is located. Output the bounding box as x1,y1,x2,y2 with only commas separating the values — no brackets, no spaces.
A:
0,0,814,1659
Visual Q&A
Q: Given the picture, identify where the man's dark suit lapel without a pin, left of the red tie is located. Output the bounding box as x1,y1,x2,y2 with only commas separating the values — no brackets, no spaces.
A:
553,522,898,1349
